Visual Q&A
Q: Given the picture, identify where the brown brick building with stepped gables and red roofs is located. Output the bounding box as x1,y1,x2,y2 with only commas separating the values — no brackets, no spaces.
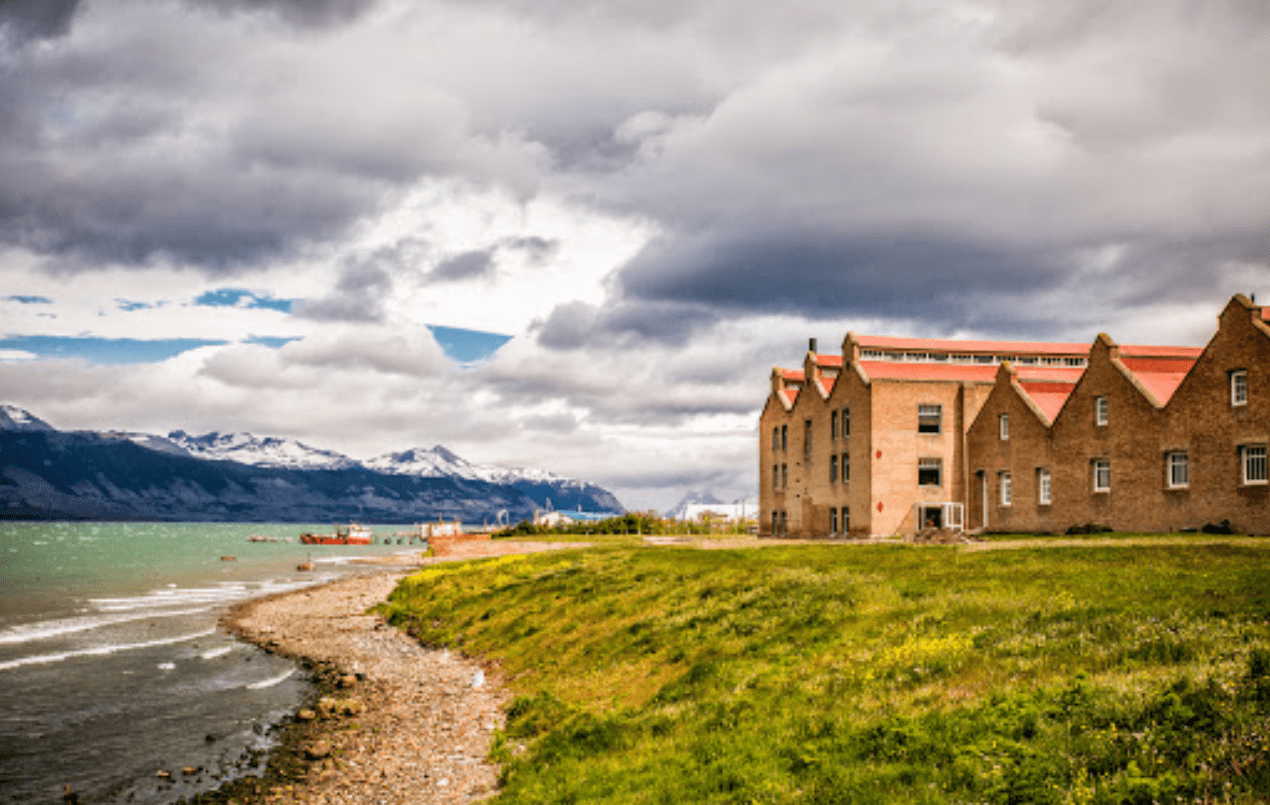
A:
759,296,1270,536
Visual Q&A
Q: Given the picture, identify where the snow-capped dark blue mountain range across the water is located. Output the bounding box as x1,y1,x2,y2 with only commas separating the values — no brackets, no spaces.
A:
0,406,622,523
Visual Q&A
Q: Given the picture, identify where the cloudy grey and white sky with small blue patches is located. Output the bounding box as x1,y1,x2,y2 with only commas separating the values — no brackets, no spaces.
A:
0,0,1270,508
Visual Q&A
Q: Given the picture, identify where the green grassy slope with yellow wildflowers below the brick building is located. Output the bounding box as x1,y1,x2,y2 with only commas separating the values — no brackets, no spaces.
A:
386,542,1270,802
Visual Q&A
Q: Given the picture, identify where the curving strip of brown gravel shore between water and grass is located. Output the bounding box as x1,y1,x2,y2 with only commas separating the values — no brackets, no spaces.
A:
222,541,579,805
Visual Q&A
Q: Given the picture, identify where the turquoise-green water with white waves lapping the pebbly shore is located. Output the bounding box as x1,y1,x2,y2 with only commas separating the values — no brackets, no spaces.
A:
0,523,420,802
